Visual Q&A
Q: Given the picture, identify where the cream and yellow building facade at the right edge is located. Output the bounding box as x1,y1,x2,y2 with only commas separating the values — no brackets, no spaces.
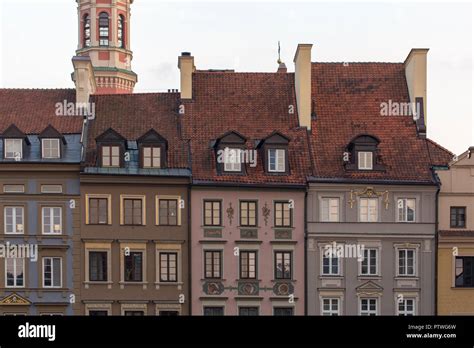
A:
436,147,474,315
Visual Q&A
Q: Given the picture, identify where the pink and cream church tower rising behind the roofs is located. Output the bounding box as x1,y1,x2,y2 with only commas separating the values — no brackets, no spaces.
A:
76,0,137,94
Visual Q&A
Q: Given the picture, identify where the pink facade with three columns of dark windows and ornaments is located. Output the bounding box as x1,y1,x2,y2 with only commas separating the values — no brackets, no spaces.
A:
191,186,305,315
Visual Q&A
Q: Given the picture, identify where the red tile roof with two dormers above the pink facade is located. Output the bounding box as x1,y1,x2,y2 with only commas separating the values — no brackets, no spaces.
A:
184,71,311,184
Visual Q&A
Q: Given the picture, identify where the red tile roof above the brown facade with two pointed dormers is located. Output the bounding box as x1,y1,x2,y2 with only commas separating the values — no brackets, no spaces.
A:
86,93,189,168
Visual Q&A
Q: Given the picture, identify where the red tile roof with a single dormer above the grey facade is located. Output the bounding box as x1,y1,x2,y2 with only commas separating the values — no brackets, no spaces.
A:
311,63,452,182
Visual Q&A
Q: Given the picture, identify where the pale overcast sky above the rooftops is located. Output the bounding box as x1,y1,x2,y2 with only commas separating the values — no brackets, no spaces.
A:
0,0,474,154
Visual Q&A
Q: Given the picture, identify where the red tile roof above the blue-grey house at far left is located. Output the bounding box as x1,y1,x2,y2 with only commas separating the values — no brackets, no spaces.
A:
0,89,83,134
